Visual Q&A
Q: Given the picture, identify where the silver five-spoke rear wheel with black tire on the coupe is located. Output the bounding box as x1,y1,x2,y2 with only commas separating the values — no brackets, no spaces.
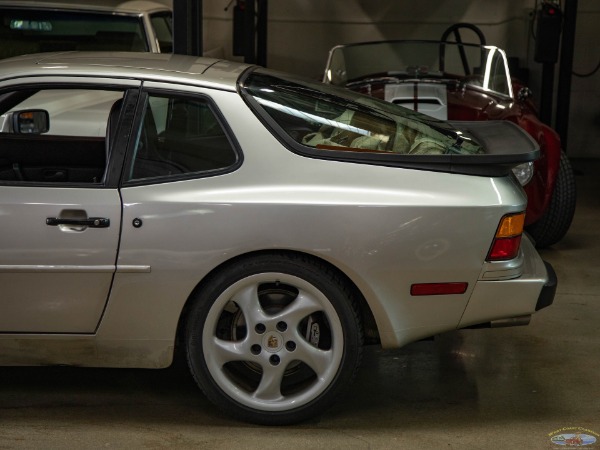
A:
185,253,362,425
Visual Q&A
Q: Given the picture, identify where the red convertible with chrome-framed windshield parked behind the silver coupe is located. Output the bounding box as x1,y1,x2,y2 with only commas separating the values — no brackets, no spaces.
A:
323,26,576,247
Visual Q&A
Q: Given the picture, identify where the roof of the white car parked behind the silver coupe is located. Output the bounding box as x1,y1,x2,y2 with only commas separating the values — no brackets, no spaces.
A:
0,0,172,14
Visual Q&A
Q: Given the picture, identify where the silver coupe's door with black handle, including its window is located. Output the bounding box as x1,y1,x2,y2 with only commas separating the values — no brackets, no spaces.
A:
0,81,139,333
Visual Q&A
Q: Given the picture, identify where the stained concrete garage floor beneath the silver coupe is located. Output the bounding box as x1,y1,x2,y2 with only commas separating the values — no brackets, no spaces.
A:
0,161,600,450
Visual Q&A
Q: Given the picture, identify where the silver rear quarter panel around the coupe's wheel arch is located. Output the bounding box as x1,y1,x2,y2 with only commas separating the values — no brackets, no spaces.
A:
98,89,525,362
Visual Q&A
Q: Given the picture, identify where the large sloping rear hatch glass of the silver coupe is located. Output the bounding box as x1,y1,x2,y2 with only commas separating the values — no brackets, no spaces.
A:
245,71,481,154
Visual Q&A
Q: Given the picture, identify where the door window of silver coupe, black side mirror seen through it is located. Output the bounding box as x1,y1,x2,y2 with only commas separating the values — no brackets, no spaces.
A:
0,89,124,185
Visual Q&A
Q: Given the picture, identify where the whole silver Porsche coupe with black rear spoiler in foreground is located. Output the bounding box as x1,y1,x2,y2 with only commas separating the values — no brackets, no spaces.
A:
0,52,556,424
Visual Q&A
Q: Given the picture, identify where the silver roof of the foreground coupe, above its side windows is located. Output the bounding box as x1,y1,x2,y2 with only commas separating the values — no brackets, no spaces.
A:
0,52,251,90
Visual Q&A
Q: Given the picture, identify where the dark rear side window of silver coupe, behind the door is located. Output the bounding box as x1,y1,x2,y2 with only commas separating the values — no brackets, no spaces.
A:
128,95,237,180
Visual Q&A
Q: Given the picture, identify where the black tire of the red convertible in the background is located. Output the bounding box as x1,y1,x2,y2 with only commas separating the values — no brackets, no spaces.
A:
527,151,577,248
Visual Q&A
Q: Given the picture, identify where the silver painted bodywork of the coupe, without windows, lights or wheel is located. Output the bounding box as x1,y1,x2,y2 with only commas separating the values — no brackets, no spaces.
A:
0,54,547,368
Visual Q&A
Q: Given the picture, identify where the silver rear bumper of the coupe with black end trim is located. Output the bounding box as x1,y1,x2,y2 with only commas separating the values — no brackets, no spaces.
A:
458,236,557,328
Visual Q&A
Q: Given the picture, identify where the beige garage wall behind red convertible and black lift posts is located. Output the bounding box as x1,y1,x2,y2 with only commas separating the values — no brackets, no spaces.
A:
204,0,600,157
